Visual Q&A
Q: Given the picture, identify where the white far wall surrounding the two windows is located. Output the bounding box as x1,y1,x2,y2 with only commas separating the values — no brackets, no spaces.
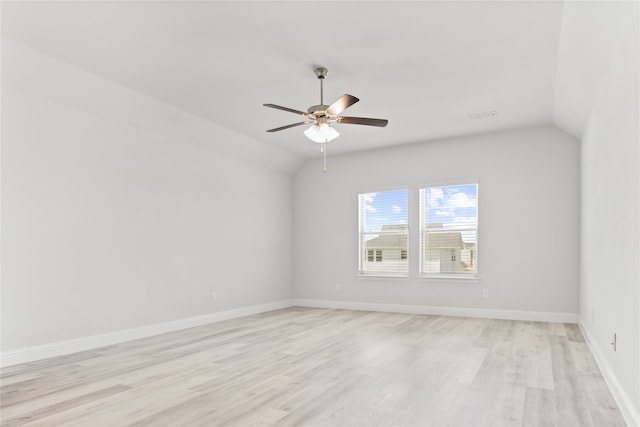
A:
294,127,579,318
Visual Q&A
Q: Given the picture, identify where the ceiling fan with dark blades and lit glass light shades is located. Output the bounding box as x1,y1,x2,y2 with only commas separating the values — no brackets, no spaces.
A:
263,67,389,172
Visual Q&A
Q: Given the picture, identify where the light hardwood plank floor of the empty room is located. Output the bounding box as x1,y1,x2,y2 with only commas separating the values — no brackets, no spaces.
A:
1,307,626,427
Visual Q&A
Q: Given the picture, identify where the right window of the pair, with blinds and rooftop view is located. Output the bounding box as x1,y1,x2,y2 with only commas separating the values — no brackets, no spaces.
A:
420,183,478,277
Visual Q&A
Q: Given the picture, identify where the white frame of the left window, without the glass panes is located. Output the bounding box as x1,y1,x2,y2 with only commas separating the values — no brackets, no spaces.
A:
358,190,411,278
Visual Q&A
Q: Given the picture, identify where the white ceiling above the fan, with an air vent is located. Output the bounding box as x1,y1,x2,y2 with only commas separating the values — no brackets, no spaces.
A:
2,1,563,158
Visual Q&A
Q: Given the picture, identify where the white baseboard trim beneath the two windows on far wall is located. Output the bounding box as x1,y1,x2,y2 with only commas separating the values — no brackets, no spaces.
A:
293,299,578,323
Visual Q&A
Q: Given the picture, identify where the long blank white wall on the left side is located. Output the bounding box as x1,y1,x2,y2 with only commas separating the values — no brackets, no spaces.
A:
1,41,292,352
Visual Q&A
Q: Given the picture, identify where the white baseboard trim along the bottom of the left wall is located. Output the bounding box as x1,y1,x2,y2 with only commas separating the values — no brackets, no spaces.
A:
0,300,293,367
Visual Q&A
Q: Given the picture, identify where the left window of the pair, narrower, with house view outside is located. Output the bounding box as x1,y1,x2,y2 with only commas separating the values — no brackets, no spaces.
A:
358,190,409,276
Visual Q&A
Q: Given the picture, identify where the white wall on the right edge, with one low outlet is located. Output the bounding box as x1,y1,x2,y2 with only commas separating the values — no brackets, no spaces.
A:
576,2,640,425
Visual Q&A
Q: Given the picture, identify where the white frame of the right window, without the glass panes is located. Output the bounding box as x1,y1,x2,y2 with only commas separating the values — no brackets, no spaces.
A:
418,179,480,281
